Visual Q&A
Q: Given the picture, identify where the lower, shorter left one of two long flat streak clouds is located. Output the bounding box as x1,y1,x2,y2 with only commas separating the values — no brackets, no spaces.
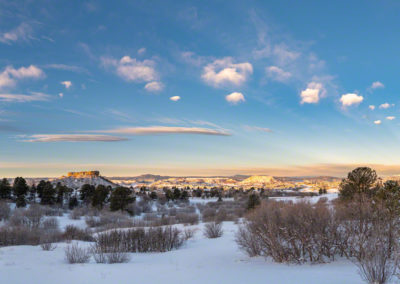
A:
22,134,128,142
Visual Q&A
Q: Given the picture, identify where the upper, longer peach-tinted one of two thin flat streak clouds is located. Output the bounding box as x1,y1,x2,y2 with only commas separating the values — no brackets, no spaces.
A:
96,126,231,136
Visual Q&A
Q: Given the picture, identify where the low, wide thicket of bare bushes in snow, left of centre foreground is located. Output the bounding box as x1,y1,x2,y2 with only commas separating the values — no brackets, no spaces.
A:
96,227,185,253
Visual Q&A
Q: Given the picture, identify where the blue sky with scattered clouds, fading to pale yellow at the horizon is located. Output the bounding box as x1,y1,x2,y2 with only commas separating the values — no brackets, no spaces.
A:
0,0,400,177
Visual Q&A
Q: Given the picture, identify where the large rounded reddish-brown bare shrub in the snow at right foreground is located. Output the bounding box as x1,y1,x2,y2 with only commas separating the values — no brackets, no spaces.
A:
236,201,338,263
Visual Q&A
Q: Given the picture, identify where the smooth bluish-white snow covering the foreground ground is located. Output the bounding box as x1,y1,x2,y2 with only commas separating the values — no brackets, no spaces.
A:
0,219,363,284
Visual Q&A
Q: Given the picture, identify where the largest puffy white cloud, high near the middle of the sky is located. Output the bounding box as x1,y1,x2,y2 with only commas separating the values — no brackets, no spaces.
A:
201,57,253,87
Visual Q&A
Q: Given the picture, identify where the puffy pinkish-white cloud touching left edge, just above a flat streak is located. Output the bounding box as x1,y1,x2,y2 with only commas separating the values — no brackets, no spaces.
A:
0,65,45,89
